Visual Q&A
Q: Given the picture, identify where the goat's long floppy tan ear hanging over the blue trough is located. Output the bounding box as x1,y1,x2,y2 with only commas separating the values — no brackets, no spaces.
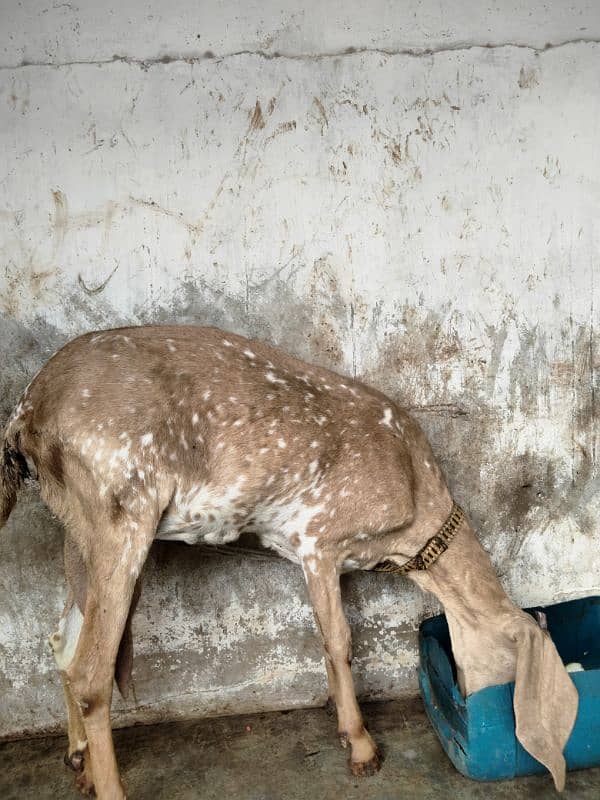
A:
514,620,578,792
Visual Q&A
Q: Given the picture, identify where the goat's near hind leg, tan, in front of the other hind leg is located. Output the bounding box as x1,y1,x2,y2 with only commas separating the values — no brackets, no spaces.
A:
64,525,153,800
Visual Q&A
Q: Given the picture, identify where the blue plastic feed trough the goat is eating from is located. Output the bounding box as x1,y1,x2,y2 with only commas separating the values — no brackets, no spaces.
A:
419,597,600,781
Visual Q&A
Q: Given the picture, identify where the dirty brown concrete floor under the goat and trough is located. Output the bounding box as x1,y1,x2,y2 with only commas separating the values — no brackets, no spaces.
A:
0,699,600,800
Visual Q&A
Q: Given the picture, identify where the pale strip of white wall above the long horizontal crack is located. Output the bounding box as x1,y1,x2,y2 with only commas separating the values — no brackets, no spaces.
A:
0,0,600,66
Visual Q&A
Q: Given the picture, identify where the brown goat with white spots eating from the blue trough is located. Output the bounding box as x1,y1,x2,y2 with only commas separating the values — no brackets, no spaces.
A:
0,326,577,800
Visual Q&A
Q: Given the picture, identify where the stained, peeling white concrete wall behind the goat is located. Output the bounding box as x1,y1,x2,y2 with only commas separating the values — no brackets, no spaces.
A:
0,0,600,735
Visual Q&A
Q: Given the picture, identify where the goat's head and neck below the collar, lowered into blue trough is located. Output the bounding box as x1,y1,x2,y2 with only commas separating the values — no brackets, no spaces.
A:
411,525,578,791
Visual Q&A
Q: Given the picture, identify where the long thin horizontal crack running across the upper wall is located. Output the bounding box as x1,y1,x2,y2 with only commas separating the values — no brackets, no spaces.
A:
0,38,600,71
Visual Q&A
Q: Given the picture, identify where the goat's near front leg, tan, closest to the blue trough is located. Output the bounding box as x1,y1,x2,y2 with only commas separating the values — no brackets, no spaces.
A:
305,560,379,776
